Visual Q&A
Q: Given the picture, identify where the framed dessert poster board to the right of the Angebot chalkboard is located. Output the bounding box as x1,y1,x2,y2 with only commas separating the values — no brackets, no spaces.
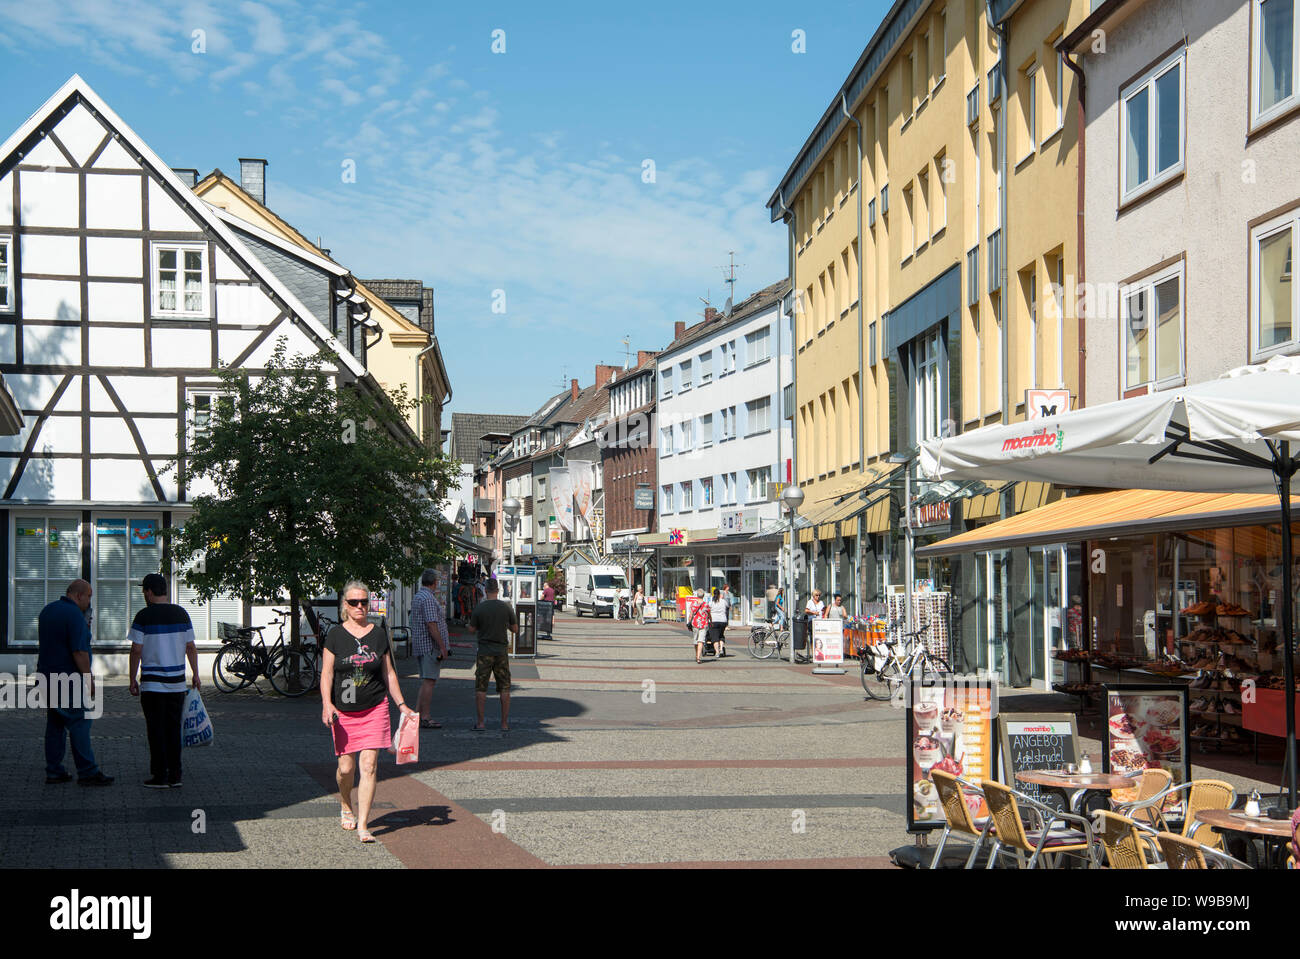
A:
1102,685,1192,815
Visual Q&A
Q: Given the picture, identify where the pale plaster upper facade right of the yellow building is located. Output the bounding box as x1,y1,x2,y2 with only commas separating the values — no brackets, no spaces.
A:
1066,0,1300,405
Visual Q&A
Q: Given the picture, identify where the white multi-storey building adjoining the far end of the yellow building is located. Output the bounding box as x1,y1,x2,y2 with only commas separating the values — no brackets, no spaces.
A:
644,281,794,622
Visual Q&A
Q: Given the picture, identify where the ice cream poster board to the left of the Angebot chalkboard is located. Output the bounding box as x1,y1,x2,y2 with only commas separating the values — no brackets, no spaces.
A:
905,680,997,832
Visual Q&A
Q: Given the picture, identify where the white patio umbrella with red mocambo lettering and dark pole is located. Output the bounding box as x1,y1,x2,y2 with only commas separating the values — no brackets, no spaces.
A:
920,356,1300,808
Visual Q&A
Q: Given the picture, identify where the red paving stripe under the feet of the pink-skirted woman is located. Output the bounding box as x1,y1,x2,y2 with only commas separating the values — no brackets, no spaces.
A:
300,761,547,869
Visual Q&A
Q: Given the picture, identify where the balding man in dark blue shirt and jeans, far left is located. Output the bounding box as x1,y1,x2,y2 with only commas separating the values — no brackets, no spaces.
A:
36,580,113,786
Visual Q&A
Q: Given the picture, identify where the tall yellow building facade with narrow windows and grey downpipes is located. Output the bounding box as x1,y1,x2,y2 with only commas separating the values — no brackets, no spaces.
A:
768,0,1088,685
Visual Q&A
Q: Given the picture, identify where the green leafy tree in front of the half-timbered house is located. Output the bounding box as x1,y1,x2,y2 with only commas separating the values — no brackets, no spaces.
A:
168,338,458,647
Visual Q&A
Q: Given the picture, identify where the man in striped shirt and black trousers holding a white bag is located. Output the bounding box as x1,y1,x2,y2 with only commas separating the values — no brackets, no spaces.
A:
130,573,202,789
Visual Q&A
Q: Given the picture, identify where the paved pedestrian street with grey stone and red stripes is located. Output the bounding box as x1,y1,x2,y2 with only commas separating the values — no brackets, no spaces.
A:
0,615,1266,869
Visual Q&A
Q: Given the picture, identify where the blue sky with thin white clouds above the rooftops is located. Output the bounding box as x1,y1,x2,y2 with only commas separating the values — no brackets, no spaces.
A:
0,0,888,425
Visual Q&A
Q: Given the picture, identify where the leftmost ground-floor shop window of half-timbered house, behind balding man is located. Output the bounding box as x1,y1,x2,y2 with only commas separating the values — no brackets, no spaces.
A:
12,513,81,643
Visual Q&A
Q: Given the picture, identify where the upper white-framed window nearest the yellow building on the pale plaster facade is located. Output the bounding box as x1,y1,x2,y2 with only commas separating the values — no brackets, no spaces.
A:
1119,48,1187,200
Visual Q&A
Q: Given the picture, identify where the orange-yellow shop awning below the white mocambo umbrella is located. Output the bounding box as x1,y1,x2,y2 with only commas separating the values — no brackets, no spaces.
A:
917,490,1300,556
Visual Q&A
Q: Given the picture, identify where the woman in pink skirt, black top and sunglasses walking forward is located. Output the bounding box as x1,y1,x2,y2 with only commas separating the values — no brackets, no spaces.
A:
321,580,416,842
